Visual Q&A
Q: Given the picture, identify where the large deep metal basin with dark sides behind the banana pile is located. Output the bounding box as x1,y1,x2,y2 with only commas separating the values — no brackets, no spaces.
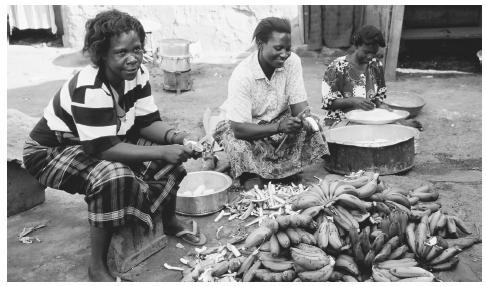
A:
324,124,418,175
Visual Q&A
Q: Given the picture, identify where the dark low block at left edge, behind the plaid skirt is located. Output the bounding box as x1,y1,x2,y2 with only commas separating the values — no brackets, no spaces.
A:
7,161,46,216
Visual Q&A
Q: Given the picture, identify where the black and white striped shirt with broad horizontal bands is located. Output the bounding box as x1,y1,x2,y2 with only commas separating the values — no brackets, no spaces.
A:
30,65,160,154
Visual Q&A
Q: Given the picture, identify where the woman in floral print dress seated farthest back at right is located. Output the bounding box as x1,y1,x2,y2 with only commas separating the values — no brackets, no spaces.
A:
322,25,422,129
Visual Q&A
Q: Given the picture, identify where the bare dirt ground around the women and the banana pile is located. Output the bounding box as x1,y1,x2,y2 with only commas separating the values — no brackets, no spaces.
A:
7,46,482,281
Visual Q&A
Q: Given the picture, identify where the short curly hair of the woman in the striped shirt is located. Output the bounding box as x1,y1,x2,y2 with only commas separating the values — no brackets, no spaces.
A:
83,9,145,67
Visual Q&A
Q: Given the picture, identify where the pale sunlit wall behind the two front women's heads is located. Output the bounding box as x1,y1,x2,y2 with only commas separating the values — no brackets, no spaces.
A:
62,5,303,57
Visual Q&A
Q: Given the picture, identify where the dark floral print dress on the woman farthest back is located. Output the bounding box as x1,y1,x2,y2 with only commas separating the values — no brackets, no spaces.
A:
321,56,386,121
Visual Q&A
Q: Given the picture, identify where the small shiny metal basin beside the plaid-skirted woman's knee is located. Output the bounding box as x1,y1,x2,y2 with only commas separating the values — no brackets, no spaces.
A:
176,171,233,216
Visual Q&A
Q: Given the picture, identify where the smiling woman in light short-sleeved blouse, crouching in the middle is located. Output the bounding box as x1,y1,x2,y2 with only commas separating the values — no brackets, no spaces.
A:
215,17,329,190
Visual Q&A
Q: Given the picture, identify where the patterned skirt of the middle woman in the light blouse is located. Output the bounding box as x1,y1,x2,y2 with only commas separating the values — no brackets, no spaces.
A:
214,110,329,179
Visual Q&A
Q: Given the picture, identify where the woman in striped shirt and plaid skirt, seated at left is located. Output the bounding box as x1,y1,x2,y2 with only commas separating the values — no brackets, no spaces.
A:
24,10,205,281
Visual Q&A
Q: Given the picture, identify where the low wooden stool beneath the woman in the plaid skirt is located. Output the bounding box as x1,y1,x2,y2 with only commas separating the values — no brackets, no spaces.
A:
108,212,167,273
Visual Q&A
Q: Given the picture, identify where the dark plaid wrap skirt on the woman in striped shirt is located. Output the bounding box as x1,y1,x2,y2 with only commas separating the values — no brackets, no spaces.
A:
23,138,186,229
